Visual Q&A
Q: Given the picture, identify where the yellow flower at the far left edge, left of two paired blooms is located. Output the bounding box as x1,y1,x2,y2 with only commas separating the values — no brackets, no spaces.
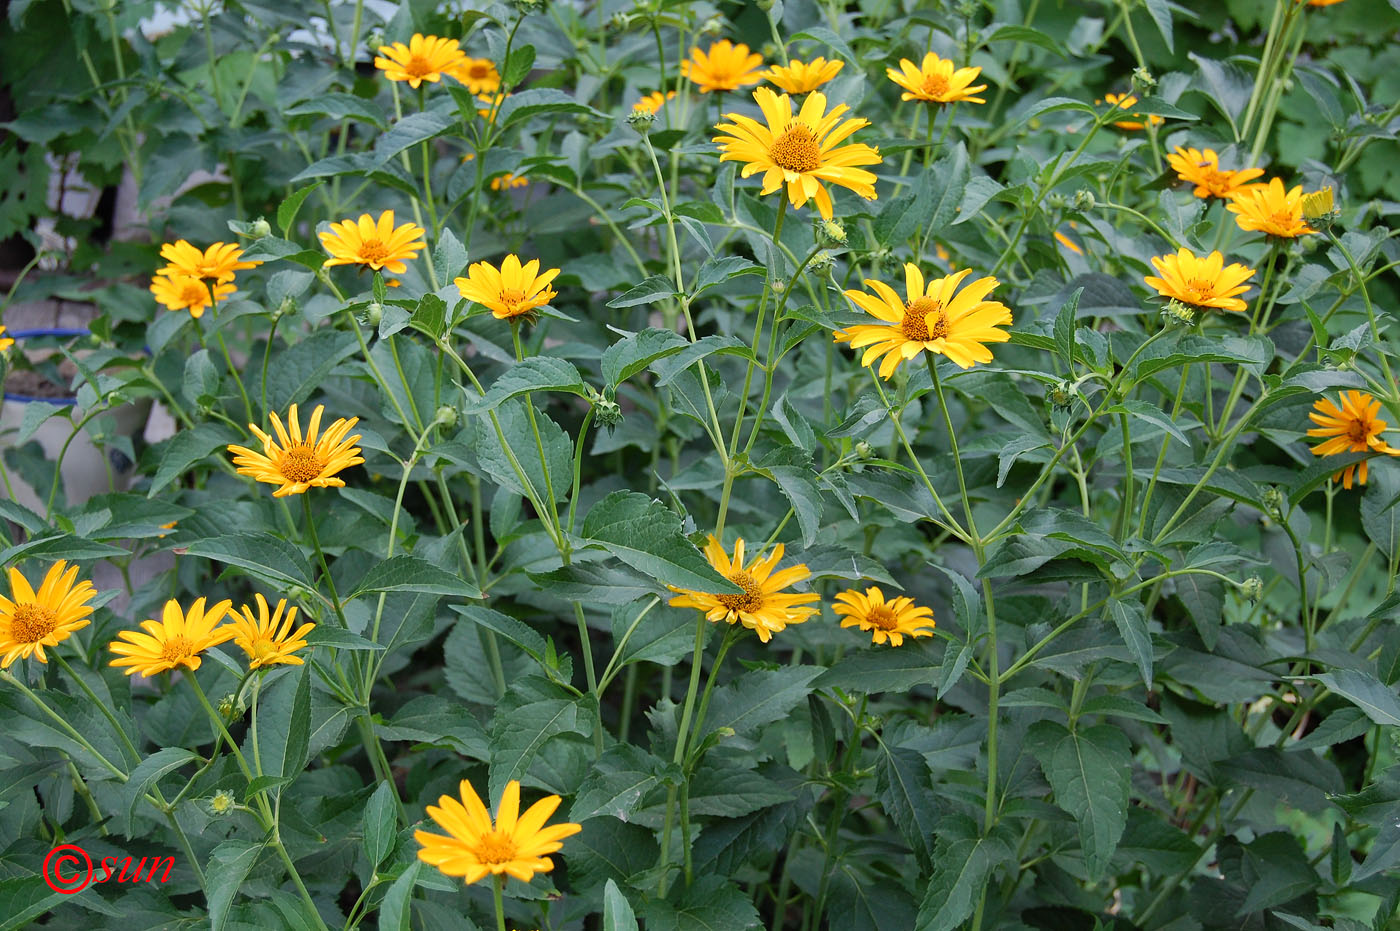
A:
0,559,97,669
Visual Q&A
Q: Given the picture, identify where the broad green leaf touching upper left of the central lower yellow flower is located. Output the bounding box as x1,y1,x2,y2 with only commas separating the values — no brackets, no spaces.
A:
582,491,741,595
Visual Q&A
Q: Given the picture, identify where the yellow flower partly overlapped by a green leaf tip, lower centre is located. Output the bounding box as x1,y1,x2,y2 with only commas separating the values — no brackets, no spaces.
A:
669,533,820,643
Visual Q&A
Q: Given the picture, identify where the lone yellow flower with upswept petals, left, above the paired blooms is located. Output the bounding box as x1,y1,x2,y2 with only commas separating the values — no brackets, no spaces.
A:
228,405,364,498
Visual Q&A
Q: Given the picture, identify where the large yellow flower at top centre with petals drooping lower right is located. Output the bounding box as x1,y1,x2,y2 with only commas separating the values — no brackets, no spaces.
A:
714,87,882,220
